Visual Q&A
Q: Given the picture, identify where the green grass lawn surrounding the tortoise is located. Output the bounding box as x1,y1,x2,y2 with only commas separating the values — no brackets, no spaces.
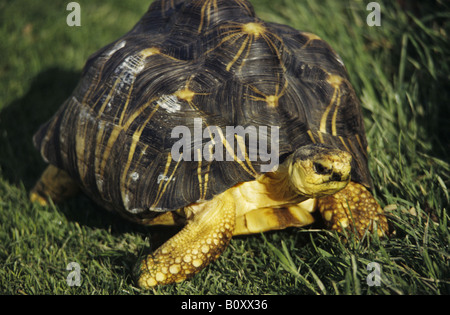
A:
0,0,450,294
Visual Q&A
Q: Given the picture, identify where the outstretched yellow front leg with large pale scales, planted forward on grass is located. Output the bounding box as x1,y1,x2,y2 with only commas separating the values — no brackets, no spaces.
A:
138,191,236,288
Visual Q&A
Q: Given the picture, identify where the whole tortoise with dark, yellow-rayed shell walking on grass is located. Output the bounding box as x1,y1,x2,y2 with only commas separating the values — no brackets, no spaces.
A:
30,0,388,288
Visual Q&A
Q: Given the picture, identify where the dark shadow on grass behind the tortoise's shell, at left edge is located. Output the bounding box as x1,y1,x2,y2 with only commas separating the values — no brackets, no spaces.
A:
0,68,80,190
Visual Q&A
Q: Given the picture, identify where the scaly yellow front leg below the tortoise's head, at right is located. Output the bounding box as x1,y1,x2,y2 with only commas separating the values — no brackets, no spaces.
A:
317,182,389,237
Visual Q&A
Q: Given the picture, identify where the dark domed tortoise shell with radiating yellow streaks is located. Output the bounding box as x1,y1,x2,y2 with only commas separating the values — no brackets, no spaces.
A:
34,0,371,221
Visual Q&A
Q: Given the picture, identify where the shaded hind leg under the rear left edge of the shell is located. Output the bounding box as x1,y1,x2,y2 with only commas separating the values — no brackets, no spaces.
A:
30,165,80,206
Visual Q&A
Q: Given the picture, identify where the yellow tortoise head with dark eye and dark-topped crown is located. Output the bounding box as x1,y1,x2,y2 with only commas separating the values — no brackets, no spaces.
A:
287,144,352,197
